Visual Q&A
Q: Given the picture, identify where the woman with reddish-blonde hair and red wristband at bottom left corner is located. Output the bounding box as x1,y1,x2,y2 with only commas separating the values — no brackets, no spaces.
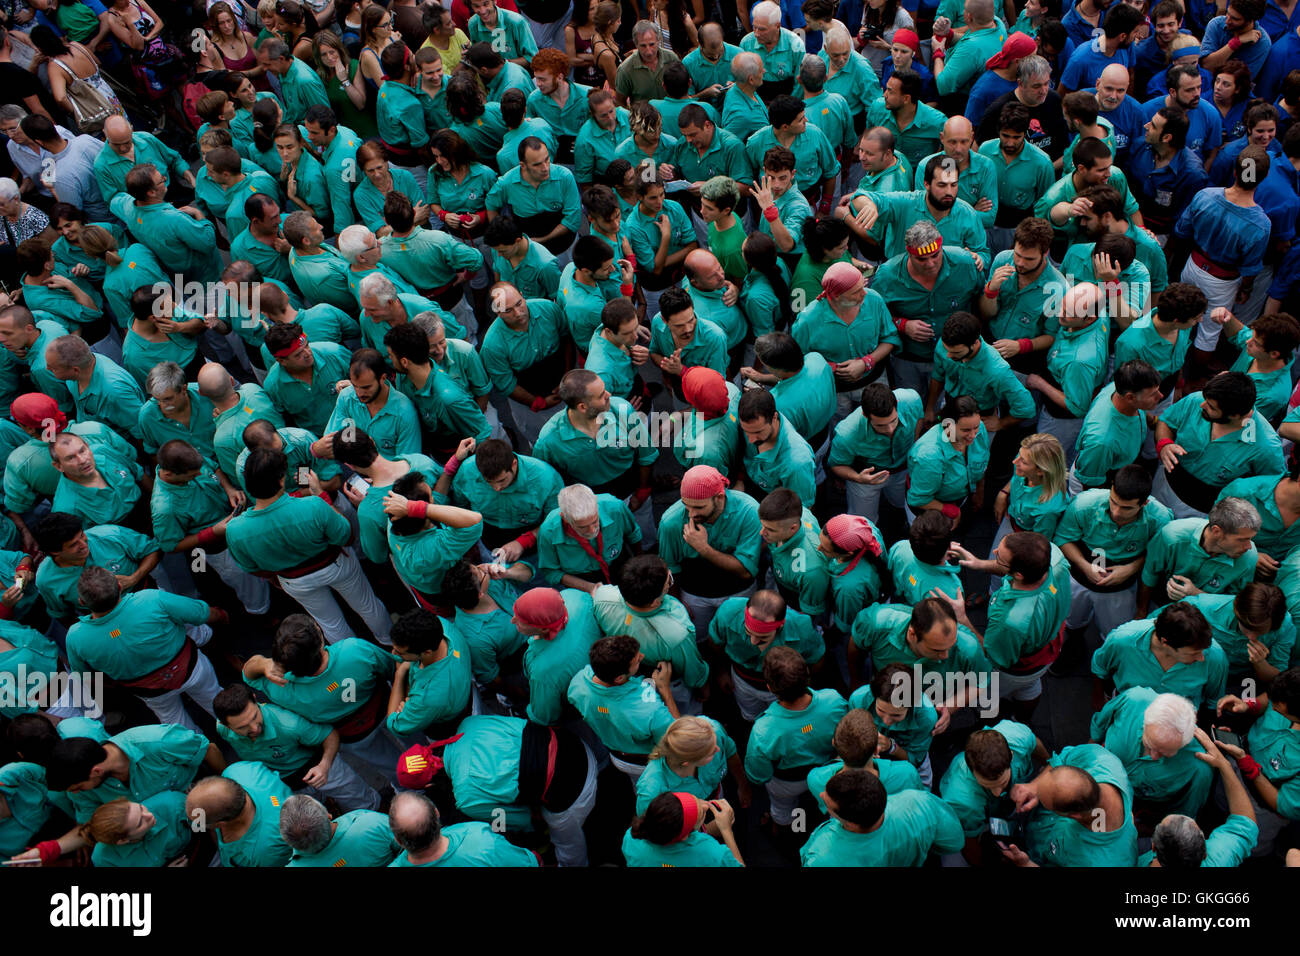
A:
80,790,195,866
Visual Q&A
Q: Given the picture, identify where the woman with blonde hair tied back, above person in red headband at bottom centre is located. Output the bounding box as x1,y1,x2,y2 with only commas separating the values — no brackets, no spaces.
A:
637,717,750,813
